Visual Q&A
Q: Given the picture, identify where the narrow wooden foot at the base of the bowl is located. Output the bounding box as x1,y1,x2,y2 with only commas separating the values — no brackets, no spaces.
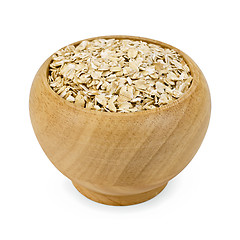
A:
73,183,167,206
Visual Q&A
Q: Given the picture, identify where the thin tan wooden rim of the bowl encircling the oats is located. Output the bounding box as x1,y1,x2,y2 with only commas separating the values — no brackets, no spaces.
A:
40,35,200,117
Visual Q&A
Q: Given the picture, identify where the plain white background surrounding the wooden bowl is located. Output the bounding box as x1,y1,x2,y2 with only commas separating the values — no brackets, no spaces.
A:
0,0,240,240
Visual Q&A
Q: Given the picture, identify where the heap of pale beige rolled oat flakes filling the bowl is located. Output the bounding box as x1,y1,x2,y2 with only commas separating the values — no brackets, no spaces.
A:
49,39,192,112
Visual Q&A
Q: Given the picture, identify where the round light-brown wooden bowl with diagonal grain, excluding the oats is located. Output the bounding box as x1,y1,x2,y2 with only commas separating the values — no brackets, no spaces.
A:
29,36,211,205
